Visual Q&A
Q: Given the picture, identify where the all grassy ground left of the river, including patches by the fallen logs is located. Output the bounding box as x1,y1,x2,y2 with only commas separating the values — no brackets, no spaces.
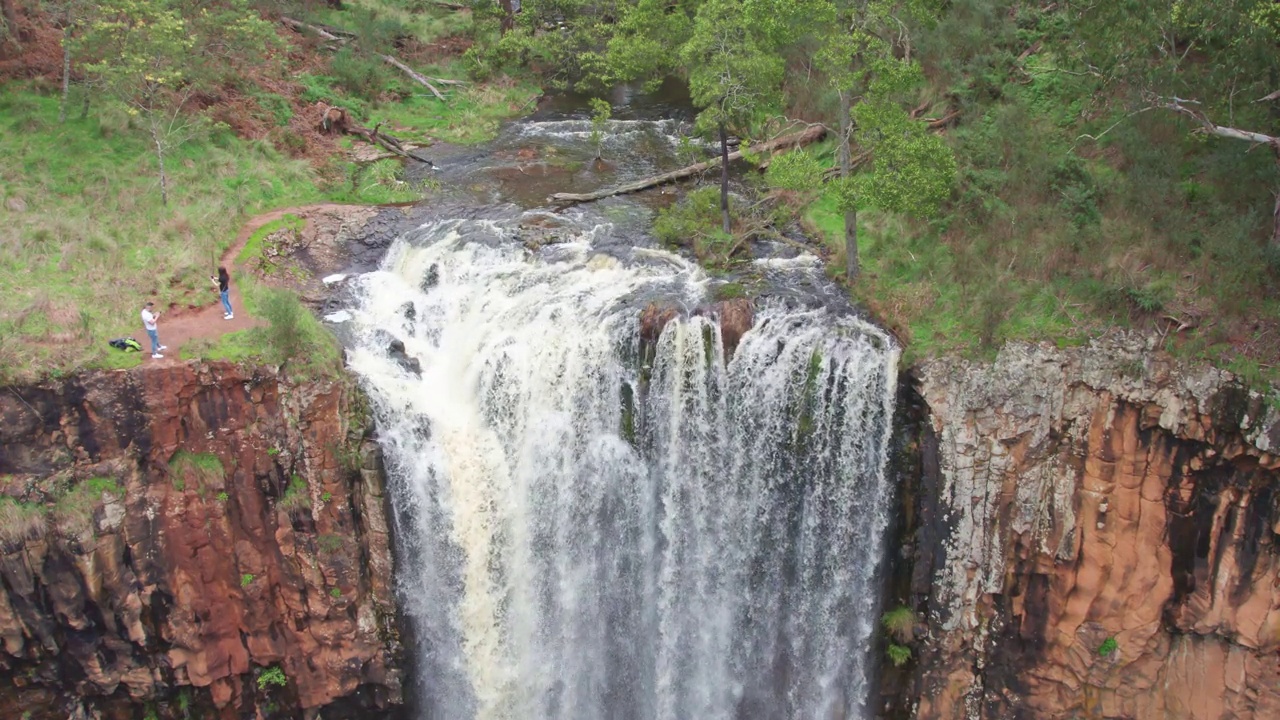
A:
0,0,536,382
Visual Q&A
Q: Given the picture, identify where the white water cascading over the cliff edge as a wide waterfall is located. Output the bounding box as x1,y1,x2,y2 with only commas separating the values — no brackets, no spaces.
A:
348,212,897,720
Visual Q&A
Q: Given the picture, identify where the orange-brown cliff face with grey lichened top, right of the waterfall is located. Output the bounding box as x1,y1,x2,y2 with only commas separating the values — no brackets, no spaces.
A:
911,338,1280,720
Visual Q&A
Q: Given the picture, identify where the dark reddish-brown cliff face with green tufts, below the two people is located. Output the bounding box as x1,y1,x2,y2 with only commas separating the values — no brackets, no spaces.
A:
0,363,401,719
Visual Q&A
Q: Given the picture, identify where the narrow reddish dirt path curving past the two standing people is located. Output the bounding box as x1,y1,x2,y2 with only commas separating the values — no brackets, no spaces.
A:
151,202,371,363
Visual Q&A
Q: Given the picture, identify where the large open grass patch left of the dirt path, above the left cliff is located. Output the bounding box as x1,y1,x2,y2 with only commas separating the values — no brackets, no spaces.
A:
0,87,325,380
